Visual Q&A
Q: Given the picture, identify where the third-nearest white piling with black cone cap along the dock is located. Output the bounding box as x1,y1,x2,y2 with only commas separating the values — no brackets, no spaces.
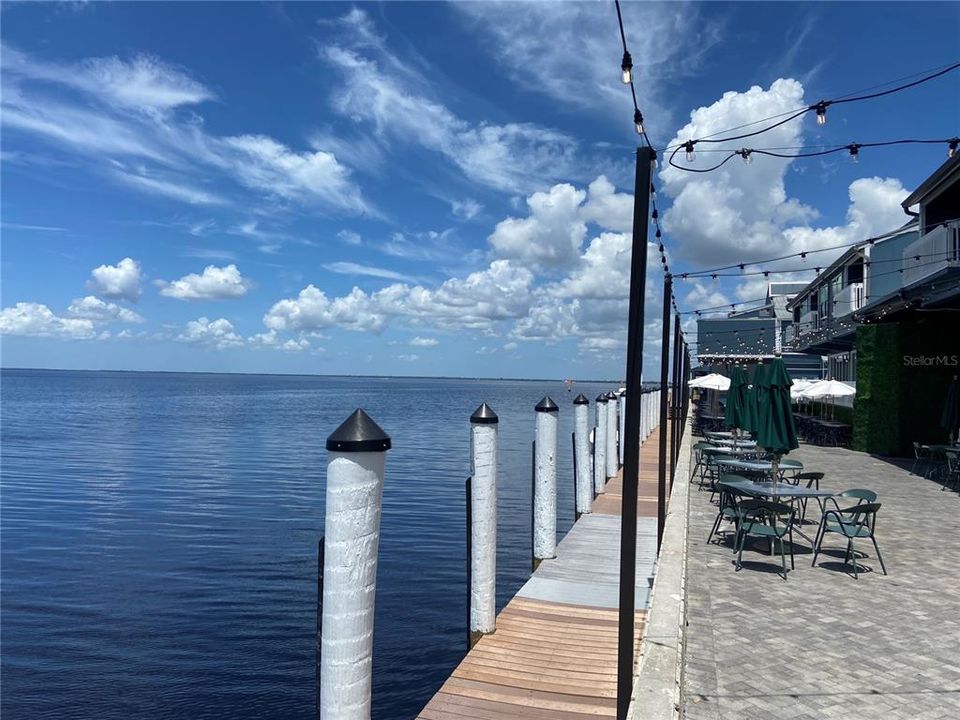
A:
533,397,560,570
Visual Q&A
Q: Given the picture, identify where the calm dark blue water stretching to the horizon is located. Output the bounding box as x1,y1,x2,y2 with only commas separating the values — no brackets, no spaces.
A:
0,370,612,720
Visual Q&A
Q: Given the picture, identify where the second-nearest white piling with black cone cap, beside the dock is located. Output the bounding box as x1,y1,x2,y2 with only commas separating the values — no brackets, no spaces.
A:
470,403,499,647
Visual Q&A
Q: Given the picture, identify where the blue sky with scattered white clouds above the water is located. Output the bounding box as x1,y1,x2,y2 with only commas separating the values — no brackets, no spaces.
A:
0,2,960,379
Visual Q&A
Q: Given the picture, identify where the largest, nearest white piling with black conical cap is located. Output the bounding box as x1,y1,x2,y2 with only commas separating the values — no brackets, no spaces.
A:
320,409,390,720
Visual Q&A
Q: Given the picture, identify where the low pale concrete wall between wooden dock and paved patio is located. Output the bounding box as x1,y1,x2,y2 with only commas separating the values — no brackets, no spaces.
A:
627,408,693,720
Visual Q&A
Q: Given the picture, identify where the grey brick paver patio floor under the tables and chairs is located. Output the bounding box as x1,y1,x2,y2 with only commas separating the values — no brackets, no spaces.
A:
682,446,960,720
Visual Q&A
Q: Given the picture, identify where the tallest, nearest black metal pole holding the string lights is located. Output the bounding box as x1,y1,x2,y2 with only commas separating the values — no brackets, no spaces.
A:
617,147,655,720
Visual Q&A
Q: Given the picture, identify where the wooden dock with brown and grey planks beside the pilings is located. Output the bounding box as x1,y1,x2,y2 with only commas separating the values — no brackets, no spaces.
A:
418,430,670,720
